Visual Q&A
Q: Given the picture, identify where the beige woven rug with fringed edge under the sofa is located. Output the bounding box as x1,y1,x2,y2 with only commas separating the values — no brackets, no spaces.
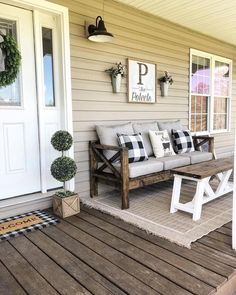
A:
81,181,232,248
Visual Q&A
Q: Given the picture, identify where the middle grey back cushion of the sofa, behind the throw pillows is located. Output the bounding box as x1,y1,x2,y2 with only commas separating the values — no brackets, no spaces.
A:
133,122,159,156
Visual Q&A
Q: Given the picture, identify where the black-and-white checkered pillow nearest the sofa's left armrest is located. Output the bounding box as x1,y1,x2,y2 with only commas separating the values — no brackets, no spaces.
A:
117,133,148,163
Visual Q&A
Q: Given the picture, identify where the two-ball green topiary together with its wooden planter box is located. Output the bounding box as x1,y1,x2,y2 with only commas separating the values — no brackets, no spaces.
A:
51,130,80,218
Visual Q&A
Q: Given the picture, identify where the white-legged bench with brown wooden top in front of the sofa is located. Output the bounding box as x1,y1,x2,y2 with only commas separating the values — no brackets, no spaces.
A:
170,158,233,221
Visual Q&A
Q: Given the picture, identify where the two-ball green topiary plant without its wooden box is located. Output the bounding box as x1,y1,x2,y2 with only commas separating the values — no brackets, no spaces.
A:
51,130,77,198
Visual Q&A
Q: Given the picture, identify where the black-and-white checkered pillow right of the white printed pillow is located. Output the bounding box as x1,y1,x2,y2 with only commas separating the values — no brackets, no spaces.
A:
172,129,195,154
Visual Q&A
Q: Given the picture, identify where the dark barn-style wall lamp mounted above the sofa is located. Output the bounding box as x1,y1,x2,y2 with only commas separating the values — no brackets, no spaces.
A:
88,16,114,42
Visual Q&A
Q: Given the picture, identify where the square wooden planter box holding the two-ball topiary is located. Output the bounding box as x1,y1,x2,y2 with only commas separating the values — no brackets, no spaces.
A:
52,194,80,218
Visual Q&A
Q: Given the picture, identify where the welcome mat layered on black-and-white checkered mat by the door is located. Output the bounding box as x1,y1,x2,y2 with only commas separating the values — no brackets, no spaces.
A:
0,210,60,241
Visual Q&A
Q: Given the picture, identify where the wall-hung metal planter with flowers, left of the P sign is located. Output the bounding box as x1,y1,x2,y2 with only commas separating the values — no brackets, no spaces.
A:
105,62,126,93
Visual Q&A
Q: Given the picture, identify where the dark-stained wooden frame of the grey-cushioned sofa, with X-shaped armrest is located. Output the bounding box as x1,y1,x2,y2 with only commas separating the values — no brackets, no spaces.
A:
89,136,214,209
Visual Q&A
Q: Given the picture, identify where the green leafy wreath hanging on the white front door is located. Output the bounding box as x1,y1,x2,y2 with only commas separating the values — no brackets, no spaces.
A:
0,34,21,87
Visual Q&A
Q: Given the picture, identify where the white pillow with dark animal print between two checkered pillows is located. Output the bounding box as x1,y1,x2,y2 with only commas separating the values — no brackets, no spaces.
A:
149,130,175,158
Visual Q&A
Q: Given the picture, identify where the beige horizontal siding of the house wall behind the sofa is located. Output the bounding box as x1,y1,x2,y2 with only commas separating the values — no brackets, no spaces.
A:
50,0,236,199
